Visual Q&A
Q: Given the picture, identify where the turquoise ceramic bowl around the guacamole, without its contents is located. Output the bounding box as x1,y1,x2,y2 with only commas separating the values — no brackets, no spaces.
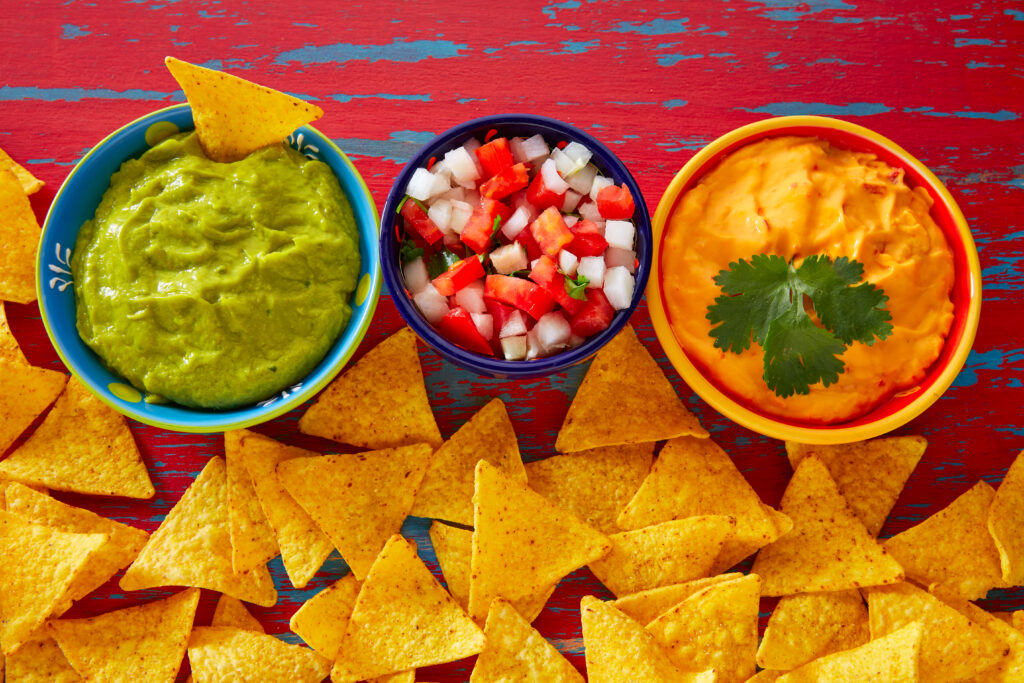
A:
36,104,381,432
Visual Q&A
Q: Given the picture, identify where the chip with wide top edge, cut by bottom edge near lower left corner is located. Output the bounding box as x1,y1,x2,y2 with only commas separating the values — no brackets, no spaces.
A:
48,589,200,683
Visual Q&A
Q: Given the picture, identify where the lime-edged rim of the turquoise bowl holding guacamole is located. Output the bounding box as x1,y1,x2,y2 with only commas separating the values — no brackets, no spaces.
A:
36,102,382,433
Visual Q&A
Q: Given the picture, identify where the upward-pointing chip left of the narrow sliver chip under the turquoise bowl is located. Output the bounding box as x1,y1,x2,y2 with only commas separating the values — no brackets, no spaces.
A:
120,457,278,607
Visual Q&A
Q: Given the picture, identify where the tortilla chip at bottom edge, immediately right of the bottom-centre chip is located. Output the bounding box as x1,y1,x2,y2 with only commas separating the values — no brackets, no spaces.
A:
580,595,715,683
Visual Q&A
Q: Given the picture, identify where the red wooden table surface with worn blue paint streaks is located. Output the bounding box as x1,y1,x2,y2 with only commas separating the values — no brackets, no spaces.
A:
0,0,1024,681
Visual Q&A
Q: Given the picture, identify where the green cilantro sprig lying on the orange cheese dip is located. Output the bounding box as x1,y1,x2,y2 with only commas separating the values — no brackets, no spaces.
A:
707,254,893,398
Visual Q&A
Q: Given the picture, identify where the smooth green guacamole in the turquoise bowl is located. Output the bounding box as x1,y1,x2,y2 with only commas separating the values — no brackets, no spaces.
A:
72,133,359,409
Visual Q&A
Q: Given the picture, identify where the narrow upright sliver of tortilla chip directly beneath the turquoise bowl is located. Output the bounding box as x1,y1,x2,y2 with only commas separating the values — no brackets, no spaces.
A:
224,430,280,571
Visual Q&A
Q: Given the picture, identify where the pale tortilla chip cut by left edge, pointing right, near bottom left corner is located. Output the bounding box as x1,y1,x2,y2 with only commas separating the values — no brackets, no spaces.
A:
0,511,110,654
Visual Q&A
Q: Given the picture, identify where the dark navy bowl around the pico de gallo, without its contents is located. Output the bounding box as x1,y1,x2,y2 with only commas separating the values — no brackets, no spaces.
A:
380,114,653,379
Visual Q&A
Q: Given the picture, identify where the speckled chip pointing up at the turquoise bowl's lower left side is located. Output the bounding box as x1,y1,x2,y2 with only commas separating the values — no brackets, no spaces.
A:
0,378,156,499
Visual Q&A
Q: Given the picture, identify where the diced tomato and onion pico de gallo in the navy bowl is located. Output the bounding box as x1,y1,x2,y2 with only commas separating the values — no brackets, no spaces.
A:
396,131,638,360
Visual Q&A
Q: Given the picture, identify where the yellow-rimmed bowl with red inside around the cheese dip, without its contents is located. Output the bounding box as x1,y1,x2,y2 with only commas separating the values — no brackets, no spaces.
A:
647,116,981,443
